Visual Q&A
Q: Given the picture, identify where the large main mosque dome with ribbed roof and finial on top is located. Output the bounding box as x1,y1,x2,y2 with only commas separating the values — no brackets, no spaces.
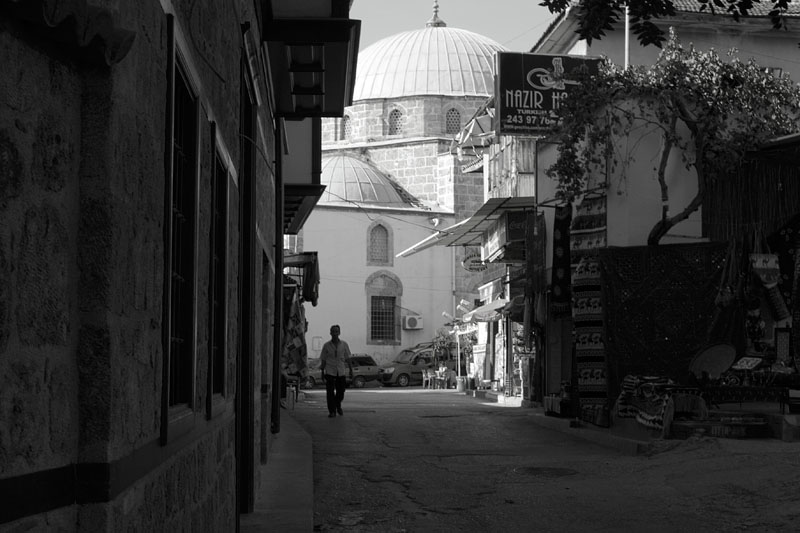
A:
353,3,506,102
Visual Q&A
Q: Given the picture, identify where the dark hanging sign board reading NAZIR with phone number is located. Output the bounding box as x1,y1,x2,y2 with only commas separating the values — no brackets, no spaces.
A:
494,52,600,136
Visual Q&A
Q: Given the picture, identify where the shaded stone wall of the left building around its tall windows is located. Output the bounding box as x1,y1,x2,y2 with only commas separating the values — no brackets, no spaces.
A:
0,0,275,532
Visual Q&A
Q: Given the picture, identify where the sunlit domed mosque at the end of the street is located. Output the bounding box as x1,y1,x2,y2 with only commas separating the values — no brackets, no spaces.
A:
299,3,505,362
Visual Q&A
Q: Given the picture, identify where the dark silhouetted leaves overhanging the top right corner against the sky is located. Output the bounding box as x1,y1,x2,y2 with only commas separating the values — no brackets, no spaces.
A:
539,0,790,47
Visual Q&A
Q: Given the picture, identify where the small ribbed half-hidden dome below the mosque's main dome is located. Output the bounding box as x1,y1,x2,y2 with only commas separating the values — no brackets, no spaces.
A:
319,154,414,207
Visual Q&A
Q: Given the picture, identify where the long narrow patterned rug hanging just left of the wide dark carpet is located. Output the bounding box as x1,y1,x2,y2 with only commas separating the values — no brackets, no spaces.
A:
572,256,609,426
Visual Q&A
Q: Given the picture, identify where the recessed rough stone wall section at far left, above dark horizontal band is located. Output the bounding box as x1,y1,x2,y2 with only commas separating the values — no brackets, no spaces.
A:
0,6,82,494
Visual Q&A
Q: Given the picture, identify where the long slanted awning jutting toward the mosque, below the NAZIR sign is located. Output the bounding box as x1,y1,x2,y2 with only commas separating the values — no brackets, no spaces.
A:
397,196,536,257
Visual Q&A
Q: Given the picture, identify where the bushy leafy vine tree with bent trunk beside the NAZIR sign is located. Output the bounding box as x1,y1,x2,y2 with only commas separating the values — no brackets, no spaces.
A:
547,30,800,244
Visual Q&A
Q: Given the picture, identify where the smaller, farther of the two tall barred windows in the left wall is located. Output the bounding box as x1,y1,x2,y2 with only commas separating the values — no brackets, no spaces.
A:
209,150,228,395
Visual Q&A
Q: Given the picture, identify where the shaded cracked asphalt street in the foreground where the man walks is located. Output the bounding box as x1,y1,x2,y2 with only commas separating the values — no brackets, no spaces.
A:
292,387,800,532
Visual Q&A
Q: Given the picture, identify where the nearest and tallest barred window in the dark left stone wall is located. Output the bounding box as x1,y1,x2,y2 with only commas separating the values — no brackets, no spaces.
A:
168,60,198,406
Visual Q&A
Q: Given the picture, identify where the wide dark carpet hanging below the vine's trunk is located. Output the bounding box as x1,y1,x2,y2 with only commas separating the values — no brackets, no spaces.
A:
600,243,727,396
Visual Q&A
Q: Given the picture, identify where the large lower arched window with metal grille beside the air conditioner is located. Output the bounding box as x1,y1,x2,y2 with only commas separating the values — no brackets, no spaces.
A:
364,270,403,344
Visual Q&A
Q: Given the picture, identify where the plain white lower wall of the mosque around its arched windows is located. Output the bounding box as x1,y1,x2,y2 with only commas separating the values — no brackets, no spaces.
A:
303,205,460,362
